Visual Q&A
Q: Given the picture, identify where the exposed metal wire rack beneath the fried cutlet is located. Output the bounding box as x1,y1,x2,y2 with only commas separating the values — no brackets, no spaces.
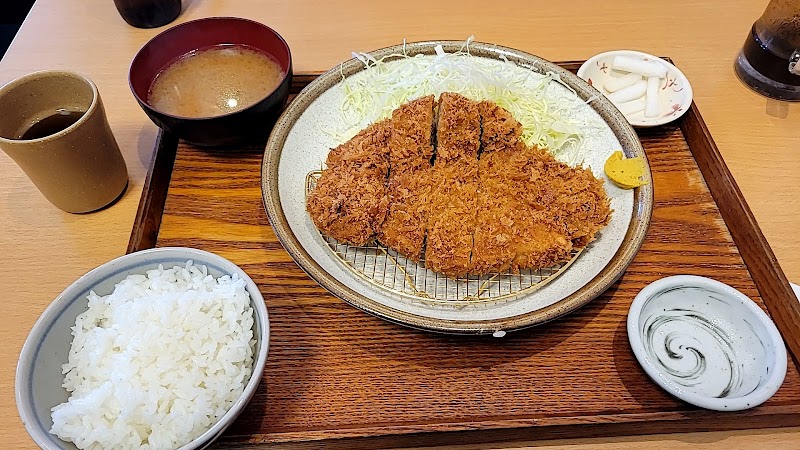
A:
306,170,581,308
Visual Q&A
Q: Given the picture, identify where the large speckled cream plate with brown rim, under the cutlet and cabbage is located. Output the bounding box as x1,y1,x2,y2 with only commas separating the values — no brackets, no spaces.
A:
262,41,653,336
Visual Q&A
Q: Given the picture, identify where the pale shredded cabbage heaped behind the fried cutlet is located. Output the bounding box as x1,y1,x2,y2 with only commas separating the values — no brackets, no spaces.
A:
329,37,583,165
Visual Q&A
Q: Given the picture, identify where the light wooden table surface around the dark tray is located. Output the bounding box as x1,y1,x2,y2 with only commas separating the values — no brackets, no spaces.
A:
0,0,800,449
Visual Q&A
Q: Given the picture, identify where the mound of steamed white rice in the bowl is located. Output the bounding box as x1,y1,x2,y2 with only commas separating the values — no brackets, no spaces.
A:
50,261,255,450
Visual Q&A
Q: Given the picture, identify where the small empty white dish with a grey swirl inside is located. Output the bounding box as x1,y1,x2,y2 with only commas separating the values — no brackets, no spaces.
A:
628,275,787,411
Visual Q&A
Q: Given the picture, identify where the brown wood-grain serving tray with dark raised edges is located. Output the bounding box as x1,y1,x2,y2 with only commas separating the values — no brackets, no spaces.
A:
128,62,800,448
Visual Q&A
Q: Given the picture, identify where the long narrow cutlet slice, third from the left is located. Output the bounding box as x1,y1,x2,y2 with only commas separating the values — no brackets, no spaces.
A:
425,93,481,276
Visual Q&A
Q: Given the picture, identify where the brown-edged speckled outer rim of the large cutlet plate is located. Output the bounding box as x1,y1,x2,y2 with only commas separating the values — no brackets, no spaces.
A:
261,41,653,334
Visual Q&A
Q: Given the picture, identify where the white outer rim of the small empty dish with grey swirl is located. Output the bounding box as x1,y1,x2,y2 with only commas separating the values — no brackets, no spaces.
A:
627,275,787,411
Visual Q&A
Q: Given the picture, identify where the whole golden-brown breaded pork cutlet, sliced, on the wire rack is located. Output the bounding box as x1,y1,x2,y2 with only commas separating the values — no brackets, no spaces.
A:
308,93,611,276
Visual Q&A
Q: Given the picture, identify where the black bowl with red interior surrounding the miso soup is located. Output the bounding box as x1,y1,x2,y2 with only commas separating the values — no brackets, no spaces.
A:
128,17,292,147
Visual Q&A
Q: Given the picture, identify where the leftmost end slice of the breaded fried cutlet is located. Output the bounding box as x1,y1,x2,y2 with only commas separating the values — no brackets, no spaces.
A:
306,120,392,245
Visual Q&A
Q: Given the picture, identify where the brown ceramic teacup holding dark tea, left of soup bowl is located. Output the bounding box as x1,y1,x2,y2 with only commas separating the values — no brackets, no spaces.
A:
0,70,128,213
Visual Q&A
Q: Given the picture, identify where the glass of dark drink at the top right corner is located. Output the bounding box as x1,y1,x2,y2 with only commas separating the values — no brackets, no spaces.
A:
734,0,800,101
